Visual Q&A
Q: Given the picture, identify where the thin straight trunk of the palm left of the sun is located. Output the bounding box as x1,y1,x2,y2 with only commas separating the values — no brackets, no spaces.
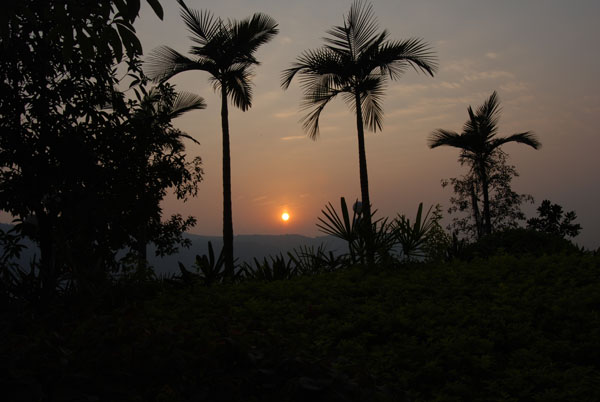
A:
221,83,234,279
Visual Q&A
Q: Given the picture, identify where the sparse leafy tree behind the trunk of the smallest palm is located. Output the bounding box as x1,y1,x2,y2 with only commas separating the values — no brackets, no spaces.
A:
442,149,533,239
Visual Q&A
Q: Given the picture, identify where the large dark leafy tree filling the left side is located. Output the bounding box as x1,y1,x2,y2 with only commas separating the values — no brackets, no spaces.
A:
0,0,201,296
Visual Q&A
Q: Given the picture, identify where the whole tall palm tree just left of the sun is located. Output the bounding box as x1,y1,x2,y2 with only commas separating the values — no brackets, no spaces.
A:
148,0,278,278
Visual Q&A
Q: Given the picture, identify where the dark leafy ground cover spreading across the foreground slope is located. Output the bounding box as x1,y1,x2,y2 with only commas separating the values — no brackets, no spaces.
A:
0,255,600,401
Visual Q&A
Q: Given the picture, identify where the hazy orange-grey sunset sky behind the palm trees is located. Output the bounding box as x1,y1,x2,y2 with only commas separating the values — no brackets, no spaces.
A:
130,0,600,248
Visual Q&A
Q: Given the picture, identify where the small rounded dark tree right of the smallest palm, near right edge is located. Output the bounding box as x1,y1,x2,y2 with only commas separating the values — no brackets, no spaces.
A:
527,200,581,237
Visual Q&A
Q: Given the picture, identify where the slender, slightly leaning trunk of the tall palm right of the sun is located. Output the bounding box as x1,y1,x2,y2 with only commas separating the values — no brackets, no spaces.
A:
354,90,375,264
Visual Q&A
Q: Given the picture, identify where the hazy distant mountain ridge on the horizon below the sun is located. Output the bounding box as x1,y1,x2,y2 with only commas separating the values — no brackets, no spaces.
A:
0,224,348,275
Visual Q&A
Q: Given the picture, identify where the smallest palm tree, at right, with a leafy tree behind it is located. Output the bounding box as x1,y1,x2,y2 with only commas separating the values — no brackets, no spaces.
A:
429,91,542,234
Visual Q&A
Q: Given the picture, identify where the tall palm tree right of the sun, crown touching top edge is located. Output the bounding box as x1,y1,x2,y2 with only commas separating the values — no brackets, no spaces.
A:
281,0,437,256
